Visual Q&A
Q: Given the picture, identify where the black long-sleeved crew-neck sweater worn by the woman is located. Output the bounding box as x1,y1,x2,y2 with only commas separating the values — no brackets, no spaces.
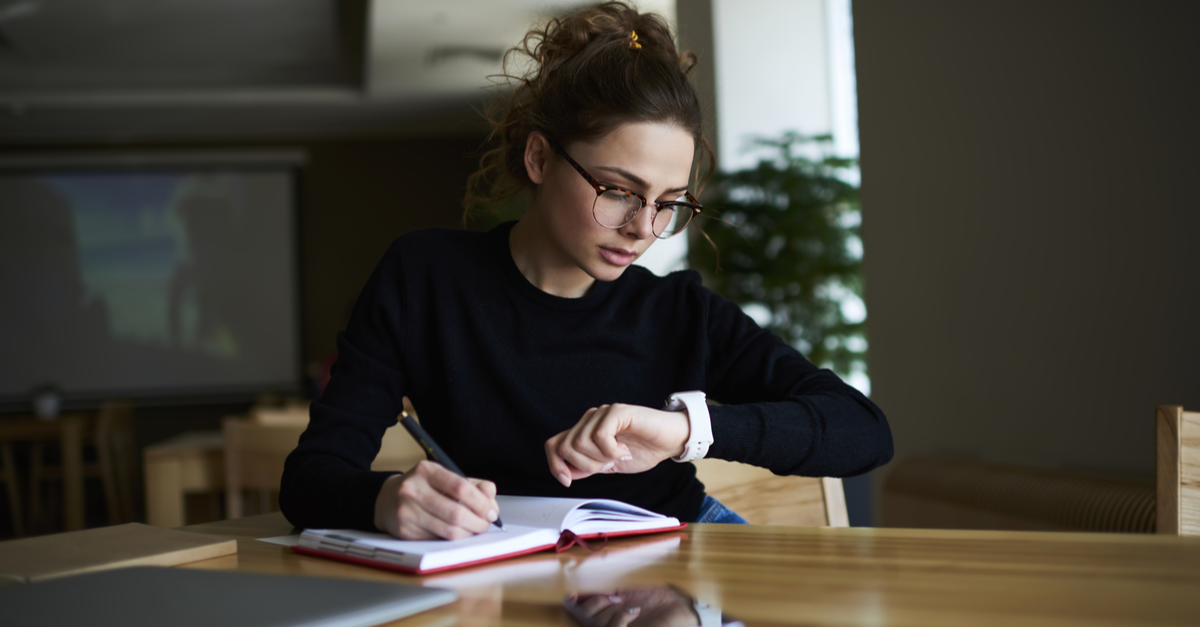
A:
280,223,892,530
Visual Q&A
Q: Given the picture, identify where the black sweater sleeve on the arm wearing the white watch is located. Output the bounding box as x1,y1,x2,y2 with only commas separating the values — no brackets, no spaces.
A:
697,281,893,477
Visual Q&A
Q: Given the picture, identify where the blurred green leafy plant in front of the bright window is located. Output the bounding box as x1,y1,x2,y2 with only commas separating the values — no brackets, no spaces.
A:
689,133,866,376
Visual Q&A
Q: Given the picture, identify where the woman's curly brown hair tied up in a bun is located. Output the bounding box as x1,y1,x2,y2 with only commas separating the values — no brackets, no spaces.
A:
463,2,716,217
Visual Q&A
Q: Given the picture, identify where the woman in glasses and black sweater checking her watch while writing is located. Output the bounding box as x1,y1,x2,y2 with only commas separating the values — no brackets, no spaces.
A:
280,2,892,539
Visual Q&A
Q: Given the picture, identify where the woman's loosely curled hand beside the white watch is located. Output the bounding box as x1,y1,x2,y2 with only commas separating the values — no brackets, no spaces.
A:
546,404,691,488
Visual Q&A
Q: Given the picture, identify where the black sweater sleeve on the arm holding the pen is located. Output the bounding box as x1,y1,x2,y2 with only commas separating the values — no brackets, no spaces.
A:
280,240,404,531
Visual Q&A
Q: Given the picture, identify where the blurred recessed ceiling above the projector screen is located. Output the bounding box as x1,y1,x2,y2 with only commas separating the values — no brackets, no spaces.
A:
0,0,674,147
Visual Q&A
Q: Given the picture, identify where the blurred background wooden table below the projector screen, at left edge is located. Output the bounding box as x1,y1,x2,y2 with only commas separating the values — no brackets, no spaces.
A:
0,413,94,531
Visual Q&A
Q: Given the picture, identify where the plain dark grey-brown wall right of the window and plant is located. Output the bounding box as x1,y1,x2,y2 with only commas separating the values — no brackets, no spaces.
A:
853,0,1200,497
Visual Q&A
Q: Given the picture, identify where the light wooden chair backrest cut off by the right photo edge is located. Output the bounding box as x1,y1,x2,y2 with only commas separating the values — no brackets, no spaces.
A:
1154,405,1200,536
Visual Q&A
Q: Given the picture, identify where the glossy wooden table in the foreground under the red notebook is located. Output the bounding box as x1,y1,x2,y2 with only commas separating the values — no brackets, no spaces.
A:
185,513,1200,627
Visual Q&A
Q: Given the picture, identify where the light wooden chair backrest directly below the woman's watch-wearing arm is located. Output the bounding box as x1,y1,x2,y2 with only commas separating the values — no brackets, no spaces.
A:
694,459,850,527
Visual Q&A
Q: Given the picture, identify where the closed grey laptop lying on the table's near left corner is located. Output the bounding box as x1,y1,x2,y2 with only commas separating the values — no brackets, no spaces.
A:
0,566,457,627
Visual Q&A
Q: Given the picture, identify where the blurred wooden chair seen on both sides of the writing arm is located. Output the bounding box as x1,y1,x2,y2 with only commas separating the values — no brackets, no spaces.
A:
222,405,425,519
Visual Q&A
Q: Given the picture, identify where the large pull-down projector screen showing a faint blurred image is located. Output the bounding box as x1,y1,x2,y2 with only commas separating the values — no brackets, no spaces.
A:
0,166,300,404
